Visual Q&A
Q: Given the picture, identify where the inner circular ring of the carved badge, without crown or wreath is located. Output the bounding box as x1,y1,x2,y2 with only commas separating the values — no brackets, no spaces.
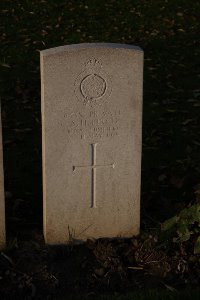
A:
80,74,106,101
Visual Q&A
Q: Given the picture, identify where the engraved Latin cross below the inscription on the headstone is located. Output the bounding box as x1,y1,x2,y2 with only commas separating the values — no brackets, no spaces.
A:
73,143,115,208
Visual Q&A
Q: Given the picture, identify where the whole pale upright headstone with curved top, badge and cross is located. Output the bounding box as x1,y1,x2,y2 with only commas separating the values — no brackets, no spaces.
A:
41,44,143,244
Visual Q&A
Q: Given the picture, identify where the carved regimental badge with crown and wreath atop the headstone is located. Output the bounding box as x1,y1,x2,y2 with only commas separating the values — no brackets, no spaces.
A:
74,58,111,106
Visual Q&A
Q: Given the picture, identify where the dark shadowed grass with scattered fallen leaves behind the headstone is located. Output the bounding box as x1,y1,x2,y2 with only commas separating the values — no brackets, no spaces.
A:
0,0,200,298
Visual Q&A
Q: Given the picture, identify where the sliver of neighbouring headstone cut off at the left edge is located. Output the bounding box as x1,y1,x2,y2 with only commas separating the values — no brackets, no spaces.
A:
0,106,6,249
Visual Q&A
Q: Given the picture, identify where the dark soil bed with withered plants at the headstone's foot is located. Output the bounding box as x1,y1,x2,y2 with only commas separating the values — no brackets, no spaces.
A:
0,231,200,299
